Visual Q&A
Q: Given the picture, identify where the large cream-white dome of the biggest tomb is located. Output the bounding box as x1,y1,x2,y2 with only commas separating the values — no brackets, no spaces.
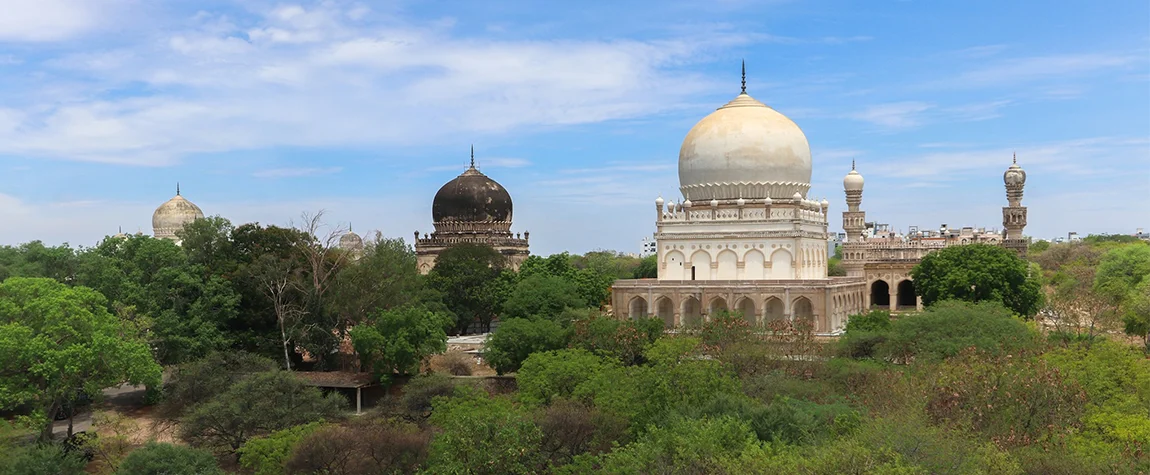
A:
679,93,811,200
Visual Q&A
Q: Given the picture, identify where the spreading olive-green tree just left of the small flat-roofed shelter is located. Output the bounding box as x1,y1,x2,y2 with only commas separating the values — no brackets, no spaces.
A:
179,370,346,452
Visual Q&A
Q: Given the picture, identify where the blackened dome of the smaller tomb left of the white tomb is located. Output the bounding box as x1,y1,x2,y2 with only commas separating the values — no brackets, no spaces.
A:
431,164,512,222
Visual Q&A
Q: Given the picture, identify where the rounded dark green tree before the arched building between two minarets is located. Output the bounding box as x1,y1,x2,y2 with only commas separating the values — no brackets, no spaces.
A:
911,244,1042,316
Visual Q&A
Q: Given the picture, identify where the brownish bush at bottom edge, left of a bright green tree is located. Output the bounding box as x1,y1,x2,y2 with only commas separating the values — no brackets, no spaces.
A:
285,420,430,475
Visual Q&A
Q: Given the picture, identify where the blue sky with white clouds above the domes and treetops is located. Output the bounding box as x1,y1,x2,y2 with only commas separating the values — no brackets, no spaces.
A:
0,0,1150,255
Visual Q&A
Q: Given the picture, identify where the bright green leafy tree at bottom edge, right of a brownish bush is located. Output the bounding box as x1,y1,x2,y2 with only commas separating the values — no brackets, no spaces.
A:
428,386,543,474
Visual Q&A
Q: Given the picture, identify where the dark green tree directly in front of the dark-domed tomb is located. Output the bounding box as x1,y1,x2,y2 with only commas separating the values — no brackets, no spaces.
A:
428,244,513,332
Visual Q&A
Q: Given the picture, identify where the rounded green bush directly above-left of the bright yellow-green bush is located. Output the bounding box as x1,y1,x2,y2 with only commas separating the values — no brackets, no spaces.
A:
483,319,567,374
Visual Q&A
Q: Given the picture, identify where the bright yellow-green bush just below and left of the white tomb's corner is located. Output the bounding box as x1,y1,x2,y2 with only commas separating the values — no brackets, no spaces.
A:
515,350,619,405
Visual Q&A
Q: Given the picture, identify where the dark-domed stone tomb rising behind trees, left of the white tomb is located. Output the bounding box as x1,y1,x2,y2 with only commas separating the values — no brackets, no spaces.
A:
415,147,530,274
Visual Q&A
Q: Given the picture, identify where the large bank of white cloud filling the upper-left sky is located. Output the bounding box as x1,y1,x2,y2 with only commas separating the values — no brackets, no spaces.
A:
0,2,745,164
